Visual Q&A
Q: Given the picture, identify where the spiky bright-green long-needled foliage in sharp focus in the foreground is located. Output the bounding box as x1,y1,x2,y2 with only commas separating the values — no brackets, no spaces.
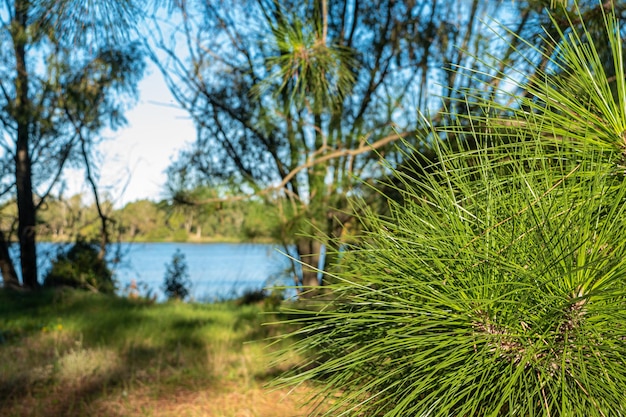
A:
280,1,626,417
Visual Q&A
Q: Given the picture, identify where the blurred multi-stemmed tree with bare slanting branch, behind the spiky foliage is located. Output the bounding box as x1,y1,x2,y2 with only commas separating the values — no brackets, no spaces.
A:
152,0,531,288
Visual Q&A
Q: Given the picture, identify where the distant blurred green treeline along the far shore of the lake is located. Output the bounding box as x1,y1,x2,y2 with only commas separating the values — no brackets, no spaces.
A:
0,195,277,242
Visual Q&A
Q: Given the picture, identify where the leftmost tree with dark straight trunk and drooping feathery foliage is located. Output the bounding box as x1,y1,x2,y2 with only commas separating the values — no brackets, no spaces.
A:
0,0,143,288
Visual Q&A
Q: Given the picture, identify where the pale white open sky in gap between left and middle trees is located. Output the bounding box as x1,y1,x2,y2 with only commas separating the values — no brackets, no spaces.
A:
64,64,196,208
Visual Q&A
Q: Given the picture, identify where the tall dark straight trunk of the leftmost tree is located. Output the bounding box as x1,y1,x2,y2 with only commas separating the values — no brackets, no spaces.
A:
12,0,39,289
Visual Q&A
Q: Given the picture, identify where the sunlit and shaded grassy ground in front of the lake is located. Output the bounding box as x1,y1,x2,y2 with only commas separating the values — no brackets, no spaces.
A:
0,290,309,417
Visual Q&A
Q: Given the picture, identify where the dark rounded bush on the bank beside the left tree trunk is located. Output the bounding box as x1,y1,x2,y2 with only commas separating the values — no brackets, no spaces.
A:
44,240,115,294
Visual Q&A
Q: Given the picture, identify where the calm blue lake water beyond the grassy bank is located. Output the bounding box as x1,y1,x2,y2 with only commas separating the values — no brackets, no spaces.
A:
37,243,291,301
